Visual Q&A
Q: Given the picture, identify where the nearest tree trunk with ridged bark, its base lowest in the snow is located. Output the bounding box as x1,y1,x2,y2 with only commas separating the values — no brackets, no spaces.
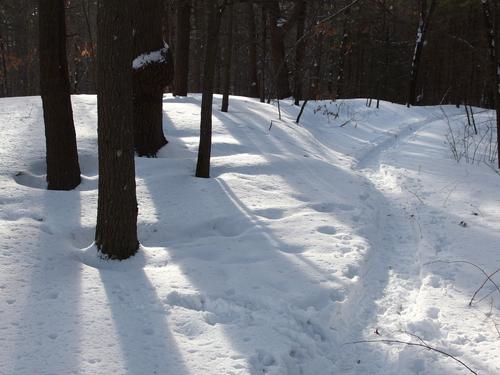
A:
95,0,139,259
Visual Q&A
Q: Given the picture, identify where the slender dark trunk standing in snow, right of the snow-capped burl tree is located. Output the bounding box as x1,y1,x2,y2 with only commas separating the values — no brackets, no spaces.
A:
196,1,226,178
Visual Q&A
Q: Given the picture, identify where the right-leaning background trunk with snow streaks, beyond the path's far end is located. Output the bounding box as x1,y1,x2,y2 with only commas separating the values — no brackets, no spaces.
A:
408,0,436,107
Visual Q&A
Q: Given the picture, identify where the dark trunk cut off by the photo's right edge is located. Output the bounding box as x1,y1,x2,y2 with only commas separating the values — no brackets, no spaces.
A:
481,0,500,168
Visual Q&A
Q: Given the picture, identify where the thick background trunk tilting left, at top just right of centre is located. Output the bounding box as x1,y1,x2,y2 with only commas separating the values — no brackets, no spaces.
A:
268,1,291,99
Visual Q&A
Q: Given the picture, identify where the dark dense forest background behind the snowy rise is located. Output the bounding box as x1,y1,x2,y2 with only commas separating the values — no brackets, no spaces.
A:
0,0,500,108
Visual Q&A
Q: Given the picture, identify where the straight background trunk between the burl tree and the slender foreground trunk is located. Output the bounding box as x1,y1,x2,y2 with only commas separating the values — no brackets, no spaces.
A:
174,0,191,96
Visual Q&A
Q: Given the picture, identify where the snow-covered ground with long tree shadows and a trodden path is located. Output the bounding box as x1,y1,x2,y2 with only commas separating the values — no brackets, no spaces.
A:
0,95,500,375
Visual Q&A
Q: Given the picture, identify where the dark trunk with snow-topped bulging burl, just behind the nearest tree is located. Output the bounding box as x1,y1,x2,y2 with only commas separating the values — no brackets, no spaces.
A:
133,0,174,157
